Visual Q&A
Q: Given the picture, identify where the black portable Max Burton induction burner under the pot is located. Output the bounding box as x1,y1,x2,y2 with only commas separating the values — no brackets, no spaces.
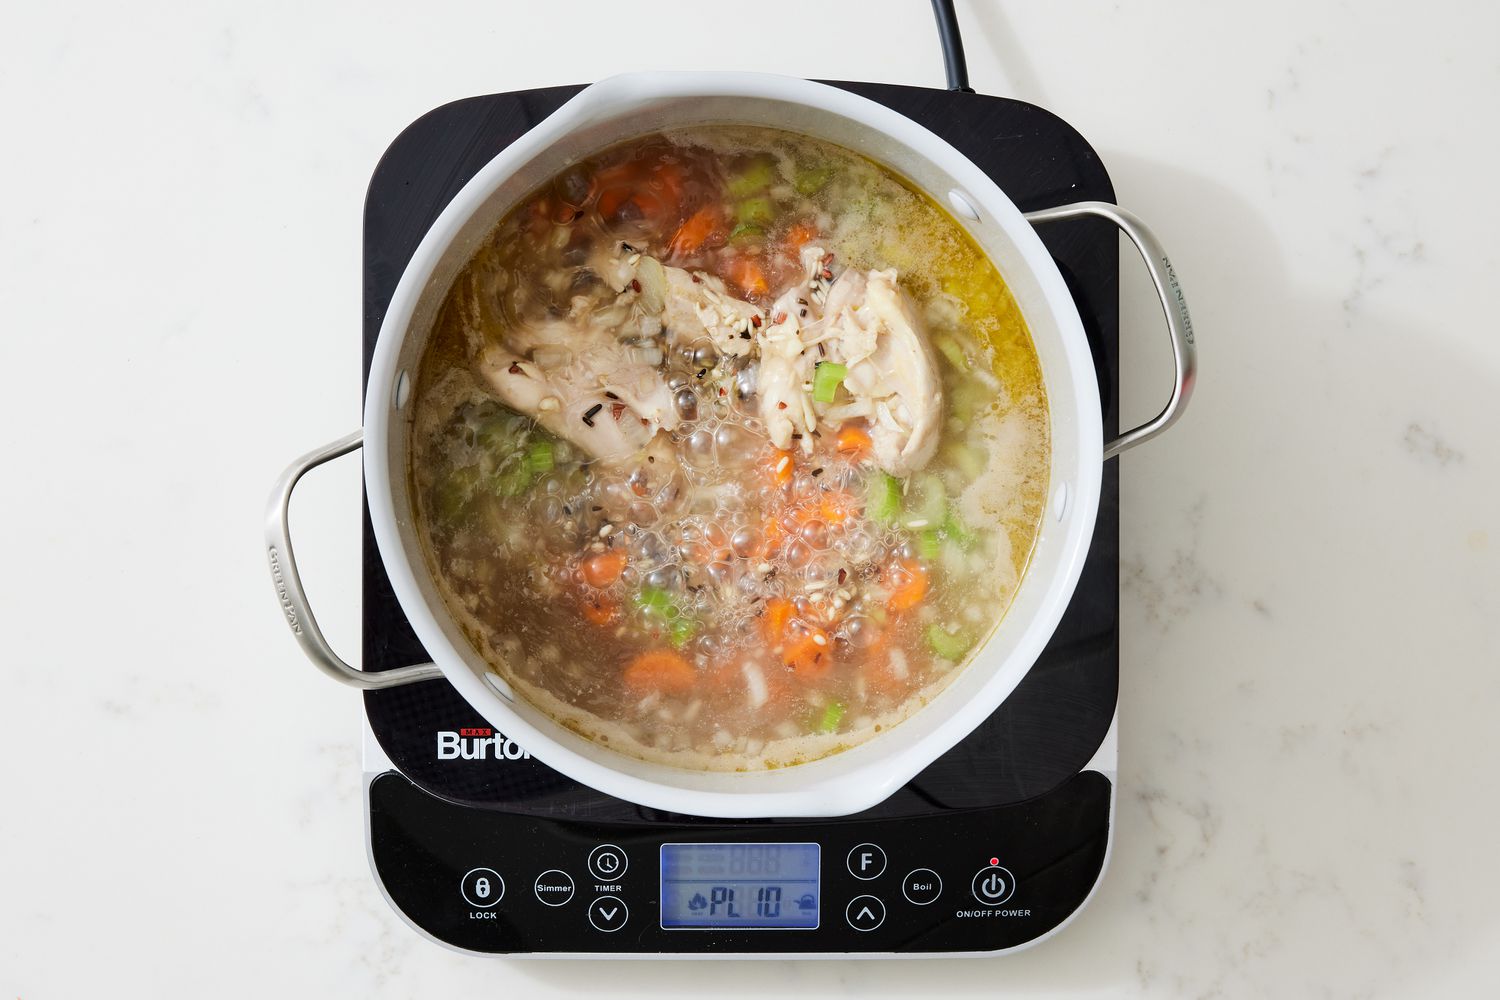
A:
363,84,1119,957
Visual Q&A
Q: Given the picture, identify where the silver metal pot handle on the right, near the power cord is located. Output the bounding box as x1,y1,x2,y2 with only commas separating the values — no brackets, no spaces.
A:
1026,201,1199,460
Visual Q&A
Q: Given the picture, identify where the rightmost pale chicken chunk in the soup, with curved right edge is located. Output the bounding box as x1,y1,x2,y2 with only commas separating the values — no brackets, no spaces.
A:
758,247,942,475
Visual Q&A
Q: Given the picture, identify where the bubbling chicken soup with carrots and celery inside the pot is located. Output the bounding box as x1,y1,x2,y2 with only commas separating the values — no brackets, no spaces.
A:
410,126,1049,769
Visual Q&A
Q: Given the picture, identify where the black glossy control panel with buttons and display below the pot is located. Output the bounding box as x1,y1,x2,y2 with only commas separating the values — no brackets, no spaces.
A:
369,771,1112,954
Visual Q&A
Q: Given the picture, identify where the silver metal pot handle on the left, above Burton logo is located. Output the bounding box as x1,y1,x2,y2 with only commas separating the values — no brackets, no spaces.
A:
266,430,443,691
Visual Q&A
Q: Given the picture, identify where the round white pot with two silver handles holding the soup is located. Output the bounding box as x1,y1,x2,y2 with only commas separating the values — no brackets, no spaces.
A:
267,72,1193,817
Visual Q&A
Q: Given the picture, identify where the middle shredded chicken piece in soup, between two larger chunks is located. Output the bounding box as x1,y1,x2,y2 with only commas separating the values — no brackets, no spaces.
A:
594,249,764,357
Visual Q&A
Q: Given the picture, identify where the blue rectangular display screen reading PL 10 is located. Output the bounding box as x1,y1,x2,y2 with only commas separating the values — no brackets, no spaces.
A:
662,844,819,931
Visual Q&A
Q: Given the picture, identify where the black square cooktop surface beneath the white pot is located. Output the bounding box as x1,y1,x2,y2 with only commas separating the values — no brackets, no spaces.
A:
363,84,1119,821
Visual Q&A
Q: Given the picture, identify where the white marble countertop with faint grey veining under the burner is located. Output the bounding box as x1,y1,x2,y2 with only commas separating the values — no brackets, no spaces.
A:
0,0,1500,1000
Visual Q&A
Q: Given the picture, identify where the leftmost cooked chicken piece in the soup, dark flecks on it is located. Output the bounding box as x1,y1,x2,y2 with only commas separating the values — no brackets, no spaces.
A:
479,321,678,462
